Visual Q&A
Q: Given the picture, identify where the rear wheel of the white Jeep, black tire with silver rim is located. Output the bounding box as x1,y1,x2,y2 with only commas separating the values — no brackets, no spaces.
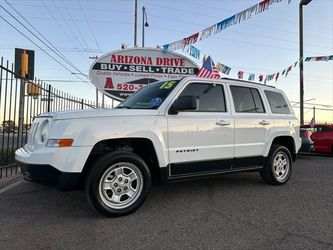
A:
260,144,293,185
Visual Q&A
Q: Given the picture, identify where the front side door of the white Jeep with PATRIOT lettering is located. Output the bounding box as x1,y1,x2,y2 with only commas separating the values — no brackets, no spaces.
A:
167,82,234,176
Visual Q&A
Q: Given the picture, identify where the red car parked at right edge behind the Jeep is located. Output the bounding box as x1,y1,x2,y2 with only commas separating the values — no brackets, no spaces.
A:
302,124,333,153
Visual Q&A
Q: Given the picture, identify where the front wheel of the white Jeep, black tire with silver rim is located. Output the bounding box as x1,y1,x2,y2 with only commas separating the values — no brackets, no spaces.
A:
86,151,151,217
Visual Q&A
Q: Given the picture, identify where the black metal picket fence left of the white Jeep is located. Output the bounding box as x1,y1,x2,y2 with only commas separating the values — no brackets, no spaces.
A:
0,58,111,168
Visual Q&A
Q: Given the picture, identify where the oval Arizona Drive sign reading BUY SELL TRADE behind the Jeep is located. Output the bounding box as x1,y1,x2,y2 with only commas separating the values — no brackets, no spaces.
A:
89,48,199,101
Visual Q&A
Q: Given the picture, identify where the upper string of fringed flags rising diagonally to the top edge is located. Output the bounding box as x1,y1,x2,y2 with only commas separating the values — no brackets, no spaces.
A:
163,0,291,51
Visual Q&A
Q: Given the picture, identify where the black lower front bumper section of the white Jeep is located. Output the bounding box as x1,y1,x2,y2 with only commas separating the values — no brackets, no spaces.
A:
18,162,81,190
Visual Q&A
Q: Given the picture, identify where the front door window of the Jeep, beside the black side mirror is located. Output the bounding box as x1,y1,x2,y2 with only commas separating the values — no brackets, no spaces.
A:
181,83,227,112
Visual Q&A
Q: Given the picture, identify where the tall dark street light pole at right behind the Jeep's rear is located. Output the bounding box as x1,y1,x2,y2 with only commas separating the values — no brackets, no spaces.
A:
299,0,312,125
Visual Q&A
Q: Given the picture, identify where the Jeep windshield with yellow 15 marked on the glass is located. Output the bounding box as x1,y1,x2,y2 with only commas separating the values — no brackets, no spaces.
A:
117,80,180,109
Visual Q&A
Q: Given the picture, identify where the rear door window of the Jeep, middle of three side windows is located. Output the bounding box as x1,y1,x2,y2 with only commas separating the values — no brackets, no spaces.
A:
230,86,265,113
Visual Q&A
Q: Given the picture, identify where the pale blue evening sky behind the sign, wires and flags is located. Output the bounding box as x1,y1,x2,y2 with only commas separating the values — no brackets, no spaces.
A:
0,0,333,121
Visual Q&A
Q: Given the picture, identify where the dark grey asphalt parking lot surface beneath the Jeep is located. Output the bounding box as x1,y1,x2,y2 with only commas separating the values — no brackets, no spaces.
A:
0,156,333,249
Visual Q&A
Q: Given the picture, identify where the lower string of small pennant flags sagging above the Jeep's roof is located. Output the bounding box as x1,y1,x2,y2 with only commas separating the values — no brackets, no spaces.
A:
192,45,333,84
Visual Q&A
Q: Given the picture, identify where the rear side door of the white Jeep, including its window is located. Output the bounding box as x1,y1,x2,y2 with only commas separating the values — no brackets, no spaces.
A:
230,85,273,168
